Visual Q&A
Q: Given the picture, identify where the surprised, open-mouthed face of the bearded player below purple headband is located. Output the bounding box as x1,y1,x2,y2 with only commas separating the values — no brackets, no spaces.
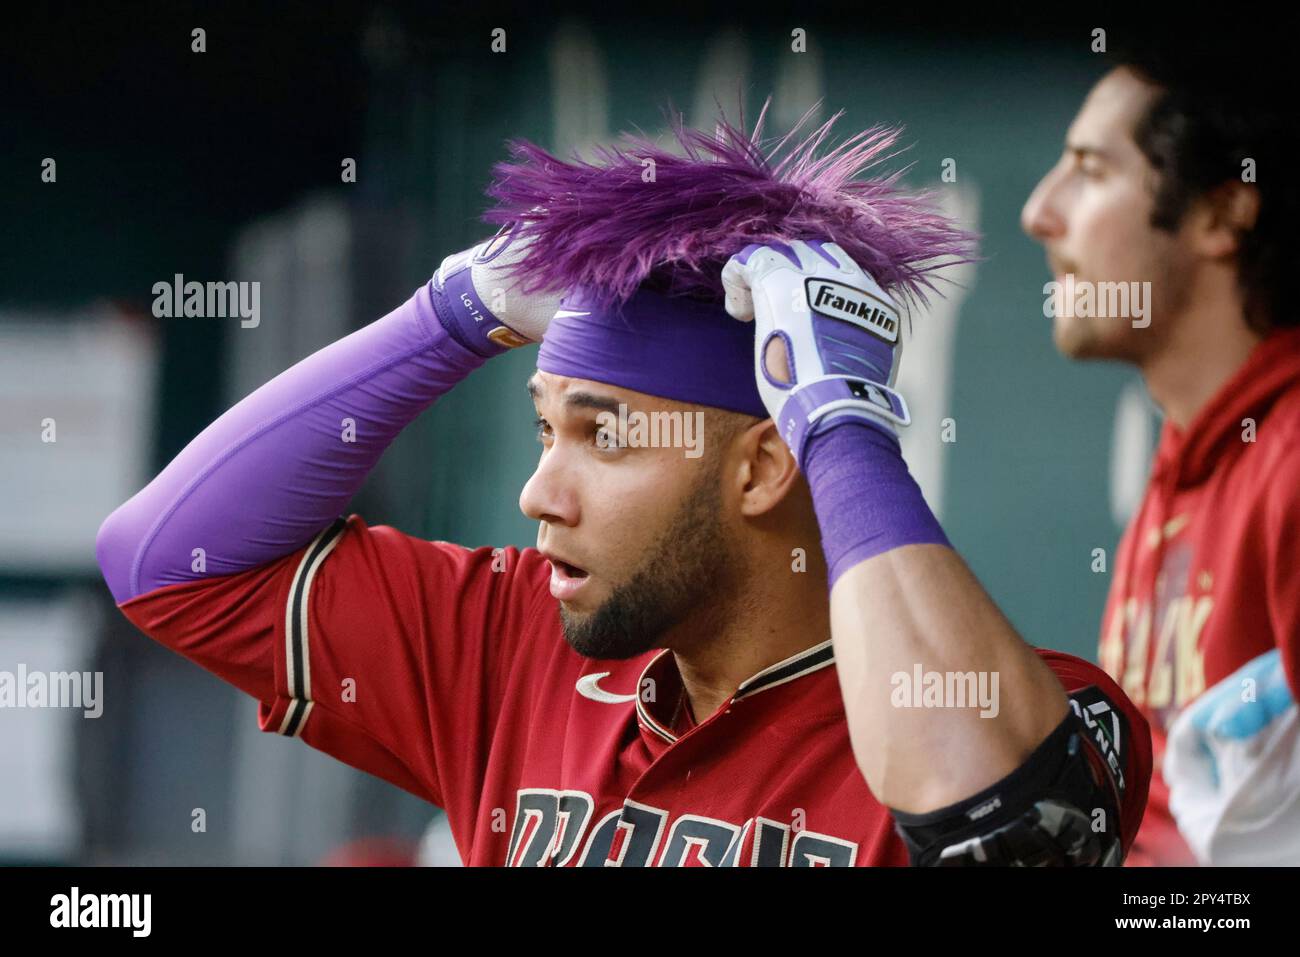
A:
519,372,733,658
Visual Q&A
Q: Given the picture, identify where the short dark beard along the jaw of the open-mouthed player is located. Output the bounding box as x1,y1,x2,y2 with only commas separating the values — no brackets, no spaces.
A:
560,475,737,661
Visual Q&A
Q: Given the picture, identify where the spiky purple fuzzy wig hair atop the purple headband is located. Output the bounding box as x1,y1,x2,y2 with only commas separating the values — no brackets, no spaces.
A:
484,100,976,304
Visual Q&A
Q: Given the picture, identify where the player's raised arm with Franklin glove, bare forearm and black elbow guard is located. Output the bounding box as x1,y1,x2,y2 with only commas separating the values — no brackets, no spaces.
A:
723,242,1138,863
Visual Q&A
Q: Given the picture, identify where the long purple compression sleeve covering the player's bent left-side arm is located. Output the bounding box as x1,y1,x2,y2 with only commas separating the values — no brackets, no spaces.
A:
95,282,486,603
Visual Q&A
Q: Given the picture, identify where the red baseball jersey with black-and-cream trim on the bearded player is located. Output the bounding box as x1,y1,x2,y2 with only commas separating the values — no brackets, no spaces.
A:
121,515,1151,867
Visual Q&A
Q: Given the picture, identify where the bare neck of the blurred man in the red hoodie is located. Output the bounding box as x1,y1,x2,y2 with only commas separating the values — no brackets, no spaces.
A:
1139,291,1261,429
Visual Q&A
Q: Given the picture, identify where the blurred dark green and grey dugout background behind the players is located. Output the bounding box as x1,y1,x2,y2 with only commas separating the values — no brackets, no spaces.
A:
0,5,1156,865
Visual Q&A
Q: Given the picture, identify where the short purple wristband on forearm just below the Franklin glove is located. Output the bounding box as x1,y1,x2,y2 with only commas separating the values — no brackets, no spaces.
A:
803,419,948,588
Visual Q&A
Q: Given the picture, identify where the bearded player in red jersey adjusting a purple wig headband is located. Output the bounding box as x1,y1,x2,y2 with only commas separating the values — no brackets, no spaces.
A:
98,106,1149,867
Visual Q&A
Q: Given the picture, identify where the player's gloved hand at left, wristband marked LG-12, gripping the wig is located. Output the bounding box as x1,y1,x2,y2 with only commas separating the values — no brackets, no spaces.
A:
433,224,563,355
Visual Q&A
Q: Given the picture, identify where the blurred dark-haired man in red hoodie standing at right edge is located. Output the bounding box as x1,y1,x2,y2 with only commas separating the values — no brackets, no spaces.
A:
1022,27,1300,865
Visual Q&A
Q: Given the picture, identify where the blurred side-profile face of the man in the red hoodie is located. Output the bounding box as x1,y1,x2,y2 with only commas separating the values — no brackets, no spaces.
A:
1021,69,1187,363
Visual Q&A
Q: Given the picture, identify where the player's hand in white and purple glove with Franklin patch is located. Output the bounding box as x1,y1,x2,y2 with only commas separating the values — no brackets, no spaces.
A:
723,241,909,464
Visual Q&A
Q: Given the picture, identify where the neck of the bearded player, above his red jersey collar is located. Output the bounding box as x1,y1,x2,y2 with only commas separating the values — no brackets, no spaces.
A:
673,535,831,722
